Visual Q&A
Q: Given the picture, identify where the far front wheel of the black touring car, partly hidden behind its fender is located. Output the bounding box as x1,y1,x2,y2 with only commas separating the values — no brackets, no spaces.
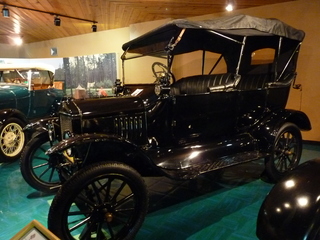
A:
20,132,61,192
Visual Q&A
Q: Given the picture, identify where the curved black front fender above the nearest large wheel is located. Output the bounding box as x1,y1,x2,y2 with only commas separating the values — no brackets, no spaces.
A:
46,133,163,176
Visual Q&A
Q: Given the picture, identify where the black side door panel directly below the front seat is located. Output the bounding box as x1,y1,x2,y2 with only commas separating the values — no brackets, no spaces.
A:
172,90,238,143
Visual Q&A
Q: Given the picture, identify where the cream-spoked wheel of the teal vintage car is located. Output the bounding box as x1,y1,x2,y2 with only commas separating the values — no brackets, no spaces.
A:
0,118,26,162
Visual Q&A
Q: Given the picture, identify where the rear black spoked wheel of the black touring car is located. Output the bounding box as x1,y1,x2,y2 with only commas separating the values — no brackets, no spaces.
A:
266,123,302,182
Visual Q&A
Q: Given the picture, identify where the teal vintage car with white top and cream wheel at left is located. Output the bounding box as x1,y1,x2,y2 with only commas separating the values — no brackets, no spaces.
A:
0,64,64,162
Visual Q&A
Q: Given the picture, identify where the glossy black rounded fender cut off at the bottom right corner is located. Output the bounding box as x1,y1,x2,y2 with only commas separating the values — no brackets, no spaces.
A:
257,159,320,240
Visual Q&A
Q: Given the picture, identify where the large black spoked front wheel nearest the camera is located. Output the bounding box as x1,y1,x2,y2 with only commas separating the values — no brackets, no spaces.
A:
48,162,148,240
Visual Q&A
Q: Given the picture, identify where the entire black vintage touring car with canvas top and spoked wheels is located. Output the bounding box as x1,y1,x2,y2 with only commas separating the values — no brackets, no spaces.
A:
21,15,311,239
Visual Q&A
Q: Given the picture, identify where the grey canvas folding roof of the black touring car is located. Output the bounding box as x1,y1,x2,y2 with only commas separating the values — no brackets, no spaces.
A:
122,15,305,56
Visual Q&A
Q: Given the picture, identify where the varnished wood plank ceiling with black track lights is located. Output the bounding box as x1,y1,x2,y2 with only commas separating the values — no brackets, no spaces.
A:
0,0,293,44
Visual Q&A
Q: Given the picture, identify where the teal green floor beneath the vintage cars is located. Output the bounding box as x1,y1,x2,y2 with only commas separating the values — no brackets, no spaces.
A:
0,144,320,240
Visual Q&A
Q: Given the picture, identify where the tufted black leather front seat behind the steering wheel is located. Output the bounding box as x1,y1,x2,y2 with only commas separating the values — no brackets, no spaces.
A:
171,73,236,95
